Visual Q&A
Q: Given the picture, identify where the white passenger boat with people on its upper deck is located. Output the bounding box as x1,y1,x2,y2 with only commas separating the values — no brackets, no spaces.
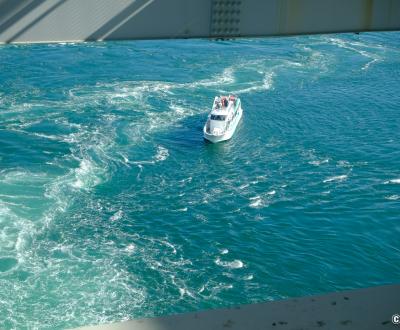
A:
203,95,243,143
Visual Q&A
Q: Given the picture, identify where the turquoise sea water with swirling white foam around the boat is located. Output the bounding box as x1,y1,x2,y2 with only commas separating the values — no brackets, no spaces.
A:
0,33,400,329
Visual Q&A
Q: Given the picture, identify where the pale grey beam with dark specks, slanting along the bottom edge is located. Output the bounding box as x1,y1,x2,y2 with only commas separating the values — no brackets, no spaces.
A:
79,285,400,330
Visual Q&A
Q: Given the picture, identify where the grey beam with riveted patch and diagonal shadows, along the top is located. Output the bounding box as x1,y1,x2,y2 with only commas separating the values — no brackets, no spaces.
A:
0,0,400,43
